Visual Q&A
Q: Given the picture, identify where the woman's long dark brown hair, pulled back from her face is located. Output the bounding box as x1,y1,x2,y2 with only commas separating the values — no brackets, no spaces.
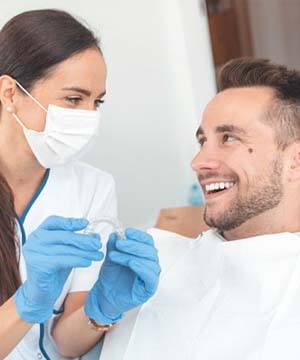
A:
0,9,101,304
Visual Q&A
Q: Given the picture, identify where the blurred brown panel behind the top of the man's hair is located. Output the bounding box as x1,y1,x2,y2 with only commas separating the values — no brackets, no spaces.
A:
206,0,300,76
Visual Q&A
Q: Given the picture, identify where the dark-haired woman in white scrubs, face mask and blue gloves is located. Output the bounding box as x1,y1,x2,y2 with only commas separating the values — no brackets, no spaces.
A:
0,10,160,360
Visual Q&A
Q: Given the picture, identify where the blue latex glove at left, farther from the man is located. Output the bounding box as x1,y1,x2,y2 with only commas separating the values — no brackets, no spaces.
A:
14,216,104,323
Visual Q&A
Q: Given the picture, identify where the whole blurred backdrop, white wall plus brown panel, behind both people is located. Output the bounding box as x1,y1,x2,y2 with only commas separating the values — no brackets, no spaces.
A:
0,0,300,228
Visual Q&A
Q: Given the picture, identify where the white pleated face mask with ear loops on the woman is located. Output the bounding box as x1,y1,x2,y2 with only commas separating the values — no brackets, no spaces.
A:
12,82,100,168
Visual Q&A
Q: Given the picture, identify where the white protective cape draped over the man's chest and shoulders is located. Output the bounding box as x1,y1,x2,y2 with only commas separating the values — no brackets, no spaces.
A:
101,229,300,360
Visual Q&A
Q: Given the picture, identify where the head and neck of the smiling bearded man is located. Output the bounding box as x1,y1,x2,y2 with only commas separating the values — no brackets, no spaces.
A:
192,61,300,240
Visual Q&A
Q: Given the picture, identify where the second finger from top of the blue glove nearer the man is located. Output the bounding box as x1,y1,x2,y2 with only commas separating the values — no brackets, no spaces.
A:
116,239,158,261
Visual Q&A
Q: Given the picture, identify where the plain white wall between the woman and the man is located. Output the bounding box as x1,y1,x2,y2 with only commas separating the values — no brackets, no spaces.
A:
0,0,215,226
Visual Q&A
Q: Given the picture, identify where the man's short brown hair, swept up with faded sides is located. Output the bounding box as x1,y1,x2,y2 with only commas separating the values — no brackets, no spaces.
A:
218,58,300,149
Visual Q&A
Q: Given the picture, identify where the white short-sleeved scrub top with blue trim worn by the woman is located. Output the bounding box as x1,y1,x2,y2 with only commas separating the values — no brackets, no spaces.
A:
5,162,117,360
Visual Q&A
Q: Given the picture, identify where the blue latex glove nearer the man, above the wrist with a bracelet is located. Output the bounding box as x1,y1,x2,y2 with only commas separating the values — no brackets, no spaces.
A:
84,229,160,324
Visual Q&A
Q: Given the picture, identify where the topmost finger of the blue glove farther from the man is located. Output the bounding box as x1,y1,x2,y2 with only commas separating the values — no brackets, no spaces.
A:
39,215,89,231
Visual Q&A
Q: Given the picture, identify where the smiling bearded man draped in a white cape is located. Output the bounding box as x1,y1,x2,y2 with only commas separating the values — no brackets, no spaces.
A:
101,59,300,360
